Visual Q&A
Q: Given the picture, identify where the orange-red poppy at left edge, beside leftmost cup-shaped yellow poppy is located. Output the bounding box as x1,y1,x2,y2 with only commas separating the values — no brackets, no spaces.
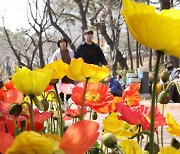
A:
0,80,23,104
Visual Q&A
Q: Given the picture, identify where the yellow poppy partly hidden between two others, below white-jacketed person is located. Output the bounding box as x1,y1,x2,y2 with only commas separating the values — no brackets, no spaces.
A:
44,59,68,80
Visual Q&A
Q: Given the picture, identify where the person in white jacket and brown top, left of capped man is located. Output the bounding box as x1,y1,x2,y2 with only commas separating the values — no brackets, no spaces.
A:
51,38,74,108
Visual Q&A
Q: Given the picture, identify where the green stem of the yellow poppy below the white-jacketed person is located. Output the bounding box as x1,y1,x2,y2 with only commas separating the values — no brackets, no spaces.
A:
54,85,64,137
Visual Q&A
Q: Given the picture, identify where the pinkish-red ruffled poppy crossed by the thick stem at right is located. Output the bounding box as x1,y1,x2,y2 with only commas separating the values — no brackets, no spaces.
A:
116,104,166,130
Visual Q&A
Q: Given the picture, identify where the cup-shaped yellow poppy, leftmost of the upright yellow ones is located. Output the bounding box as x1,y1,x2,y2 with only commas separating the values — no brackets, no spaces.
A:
12,67,52,95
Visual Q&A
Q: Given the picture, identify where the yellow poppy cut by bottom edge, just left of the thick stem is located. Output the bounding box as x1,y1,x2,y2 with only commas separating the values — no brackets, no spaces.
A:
119,139,142,154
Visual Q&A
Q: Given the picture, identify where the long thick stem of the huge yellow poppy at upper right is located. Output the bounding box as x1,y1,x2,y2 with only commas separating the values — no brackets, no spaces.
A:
149,51,163,154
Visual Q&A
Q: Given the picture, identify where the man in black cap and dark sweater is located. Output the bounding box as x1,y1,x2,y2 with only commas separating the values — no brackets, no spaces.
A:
74,30,108,66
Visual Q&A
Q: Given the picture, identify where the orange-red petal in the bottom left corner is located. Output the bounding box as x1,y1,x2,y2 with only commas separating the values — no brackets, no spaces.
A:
0,132,14,154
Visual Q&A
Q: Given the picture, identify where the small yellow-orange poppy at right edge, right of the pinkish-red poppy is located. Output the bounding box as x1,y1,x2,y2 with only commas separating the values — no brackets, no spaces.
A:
166,113,180,136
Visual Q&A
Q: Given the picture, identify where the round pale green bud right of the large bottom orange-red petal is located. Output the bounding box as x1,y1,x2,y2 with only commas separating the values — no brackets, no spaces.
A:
101,133,117,148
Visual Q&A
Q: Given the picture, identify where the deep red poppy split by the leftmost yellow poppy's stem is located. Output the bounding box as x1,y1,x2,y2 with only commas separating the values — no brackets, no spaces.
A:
27,108,51,132
